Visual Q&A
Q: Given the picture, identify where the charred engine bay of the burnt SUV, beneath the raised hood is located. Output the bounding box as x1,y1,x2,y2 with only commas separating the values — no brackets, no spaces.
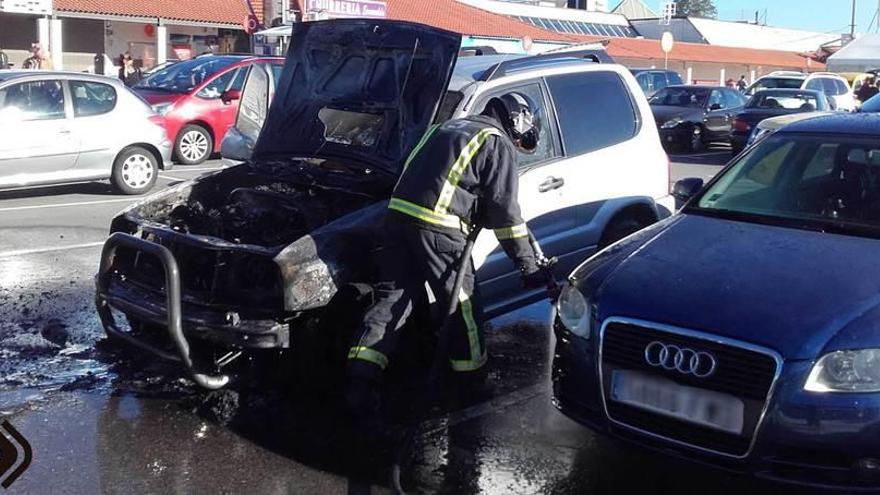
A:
135,160,390,247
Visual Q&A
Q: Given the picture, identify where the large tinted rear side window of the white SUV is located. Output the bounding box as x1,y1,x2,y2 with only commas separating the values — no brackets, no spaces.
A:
547,72,639,156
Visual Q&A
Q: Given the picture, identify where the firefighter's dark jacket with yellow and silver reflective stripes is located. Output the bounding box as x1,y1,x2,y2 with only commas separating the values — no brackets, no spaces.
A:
388,116,536,273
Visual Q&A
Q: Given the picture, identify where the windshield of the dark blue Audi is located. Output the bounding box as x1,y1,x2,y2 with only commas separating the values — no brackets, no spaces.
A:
688,133,880,234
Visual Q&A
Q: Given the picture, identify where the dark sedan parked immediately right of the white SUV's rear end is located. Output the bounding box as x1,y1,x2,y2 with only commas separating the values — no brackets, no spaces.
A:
649,86,746,153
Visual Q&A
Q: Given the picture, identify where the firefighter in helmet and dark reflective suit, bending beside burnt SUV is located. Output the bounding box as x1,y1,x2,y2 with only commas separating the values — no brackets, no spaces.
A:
346,93,546,414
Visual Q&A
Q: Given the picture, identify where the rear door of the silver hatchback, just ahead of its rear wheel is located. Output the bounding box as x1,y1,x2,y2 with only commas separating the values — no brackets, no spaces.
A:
67,80,120,177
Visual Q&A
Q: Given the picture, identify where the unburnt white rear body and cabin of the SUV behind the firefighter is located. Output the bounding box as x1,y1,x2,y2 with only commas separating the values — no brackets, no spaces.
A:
440,49,674,313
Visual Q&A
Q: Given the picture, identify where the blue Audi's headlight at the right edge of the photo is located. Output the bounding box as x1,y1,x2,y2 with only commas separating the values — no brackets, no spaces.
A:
804,349,880,392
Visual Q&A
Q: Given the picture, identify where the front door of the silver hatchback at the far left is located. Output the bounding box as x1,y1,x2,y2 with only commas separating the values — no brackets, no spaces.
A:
0,79,79,178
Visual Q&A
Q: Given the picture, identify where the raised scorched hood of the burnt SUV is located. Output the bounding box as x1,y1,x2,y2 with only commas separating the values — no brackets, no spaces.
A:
253,19,461,174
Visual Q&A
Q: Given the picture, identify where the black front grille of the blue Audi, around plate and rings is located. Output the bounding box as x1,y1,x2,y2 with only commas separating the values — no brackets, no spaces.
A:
599,318,782,458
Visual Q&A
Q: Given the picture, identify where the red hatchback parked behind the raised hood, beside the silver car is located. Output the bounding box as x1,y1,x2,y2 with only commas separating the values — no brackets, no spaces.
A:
133,55,284,165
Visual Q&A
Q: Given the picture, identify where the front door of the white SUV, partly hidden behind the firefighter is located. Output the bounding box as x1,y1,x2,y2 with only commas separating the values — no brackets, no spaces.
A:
471,79,572,314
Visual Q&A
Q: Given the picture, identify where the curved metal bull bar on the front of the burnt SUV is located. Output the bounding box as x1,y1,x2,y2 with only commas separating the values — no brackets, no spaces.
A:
95,232,229,390
